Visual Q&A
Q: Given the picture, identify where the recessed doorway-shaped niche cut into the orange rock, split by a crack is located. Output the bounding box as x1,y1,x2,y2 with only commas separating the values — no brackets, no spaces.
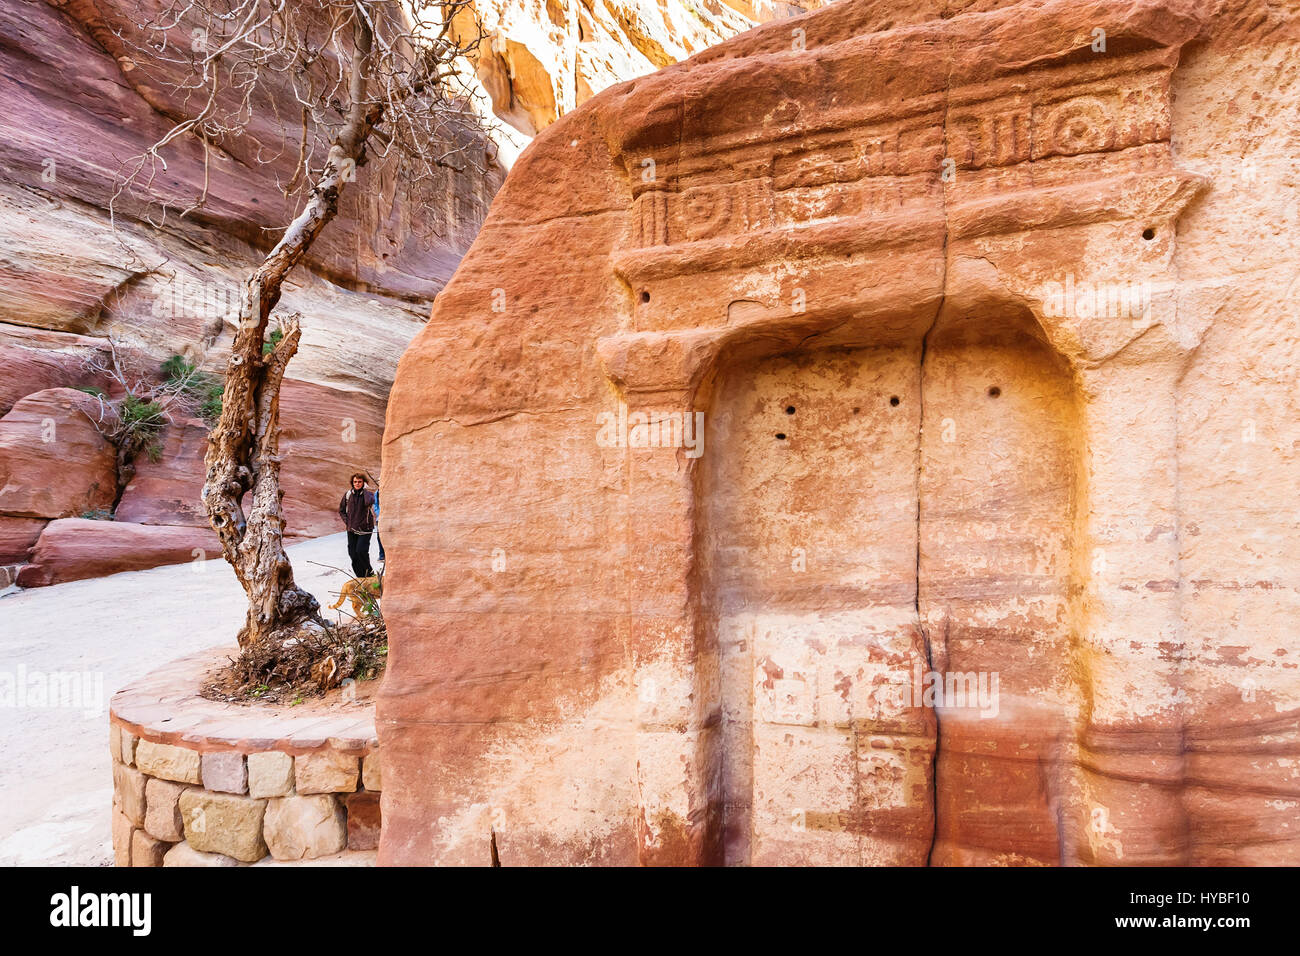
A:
699,308,1082,865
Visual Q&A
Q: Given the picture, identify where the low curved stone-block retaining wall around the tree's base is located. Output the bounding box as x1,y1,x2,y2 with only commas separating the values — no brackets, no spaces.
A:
109,648,382,866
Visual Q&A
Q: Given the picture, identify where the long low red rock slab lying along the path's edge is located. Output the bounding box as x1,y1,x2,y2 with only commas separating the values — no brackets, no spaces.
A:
18,518,221,588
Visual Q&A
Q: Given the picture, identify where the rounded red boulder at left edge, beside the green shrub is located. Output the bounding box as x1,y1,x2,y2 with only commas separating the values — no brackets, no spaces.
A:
0,389,117,518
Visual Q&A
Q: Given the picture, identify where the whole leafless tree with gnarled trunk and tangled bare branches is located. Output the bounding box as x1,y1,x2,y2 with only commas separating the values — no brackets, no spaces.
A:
109,0,485,646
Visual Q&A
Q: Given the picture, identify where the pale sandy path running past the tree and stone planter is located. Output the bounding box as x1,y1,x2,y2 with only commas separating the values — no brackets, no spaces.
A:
0,535,377,865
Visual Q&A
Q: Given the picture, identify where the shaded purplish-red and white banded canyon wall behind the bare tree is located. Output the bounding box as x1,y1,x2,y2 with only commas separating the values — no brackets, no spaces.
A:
0,0,503,574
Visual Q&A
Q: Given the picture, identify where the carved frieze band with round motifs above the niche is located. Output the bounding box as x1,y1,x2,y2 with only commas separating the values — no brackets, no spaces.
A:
621,53,1169,248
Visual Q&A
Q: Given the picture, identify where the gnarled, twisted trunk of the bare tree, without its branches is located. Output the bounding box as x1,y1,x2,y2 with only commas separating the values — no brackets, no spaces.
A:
203,17,381,648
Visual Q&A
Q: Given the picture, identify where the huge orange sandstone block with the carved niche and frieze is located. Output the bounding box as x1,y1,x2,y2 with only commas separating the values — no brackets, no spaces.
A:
378,0,1300,865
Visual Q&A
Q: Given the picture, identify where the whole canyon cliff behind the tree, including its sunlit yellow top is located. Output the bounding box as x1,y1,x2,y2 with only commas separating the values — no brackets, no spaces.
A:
0,0,759,587
